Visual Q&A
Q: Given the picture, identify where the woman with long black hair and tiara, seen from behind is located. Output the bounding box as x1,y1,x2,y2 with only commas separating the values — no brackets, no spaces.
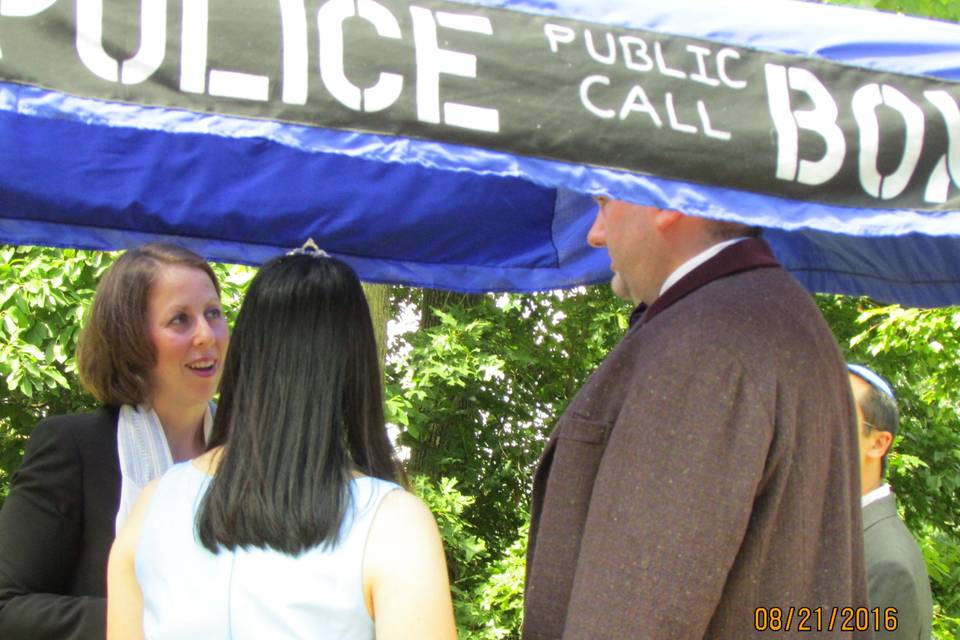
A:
107,251,456,640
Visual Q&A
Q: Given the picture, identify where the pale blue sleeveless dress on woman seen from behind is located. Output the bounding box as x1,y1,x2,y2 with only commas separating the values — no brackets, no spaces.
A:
135,462,399,640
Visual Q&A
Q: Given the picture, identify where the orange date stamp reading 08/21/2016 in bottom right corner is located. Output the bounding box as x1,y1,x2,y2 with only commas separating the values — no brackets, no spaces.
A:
753,607,898,633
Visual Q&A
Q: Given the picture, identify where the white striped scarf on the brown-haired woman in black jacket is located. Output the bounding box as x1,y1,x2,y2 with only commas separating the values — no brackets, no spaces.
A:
116,401,217,533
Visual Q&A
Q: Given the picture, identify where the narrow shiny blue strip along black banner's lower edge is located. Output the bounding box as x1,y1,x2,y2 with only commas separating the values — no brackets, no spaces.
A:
0,83,960,236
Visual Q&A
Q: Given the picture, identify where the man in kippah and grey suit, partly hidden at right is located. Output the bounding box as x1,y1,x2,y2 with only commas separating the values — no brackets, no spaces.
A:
848,364,933,640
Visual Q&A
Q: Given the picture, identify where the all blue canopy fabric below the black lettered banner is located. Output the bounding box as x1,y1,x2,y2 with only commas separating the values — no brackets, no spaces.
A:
0,79,960,306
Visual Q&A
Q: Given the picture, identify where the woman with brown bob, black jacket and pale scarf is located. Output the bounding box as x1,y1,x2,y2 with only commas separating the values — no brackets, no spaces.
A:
0,243,229,640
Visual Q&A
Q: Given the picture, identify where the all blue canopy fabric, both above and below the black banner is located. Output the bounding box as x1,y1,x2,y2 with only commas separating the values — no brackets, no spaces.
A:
0,0,960,306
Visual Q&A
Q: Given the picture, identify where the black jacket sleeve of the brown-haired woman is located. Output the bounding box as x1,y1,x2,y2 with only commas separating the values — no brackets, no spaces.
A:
0,421,106,640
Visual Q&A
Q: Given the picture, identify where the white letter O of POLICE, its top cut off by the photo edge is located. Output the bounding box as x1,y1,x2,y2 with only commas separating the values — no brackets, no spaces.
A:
77,0,167,84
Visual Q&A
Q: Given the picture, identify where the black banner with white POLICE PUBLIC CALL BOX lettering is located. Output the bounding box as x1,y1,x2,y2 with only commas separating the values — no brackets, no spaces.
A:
0,0,960,211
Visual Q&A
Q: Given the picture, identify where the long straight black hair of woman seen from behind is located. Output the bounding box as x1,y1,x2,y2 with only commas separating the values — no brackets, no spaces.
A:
197,255,401,554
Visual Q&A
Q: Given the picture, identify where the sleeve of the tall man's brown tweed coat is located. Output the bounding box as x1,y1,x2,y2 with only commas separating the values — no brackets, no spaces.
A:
563,354,773,640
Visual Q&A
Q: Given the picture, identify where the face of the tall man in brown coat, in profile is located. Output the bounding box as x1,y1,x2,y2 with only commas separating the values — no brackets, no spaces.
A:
587,196,660,304
